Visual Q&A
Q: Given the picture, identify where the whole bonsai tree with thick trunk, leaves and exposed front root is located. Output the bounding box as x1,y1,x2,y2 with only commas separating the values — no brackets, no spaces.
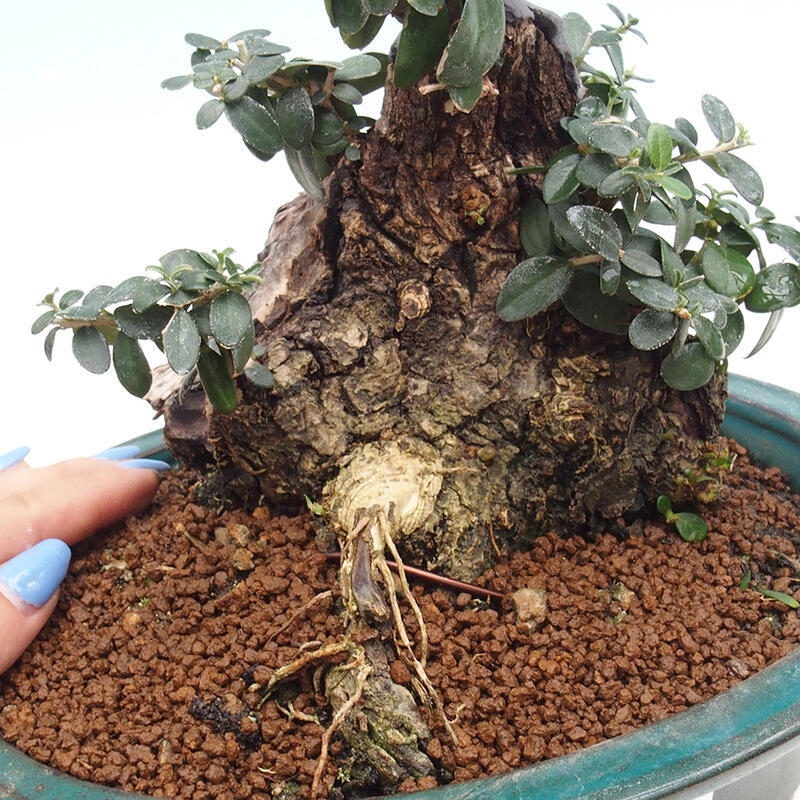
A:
34,0,800,790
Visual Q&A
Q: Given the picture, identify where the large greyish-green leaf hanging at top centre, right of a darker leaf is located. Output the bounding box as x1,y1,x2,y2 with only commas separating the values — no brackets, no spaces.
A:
436,0,506,87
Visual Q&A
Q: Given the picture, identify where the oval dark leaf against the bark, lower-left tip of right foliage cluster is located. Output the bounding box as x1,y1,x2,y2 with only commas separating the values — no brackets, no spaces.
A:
497,256,574,322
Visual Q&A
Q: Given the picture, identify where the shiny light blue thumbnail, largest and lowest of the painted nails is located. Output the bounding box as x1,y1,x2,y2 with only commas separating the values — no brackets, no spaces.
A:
0,539,71,609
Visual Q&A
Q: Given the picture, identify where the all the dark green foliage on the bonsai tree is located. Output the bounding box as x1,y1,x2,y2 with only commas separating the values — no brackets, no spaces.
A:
40,0,800,410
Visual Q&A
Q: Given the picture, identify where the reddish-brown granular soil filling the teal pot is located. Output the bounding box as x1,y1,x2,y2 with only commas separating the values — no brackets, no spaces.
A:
0,443,800,800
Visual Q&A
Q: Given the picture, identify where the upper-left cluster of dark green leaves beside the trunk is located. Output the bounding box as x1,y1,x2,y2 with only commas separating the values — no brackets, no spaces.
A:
161,30,391,202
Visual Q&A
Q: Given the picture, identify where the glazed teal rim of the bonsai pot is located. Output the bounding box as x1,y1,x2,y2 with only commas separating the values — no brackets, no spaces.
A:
0,375,800,800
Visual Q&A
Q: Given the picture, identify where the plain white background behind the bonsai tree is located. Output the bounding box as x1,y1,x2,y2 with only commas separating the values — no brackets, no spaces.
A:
0,0,800,464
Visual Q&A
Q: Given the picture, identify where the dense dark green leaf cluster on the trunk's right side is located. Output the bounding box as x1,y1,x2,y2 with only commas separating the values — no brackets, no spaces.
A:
497,6,800,390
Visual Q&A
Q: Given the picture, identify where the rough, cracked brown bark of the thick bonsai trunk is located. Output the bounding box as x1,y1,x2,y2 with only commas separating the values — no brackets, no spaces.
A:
155,14,724,579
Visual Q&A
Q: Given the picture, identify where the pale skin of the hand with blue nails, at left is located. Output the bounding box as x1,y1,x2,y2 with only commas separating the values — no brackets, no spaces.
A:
0,458,158,674
